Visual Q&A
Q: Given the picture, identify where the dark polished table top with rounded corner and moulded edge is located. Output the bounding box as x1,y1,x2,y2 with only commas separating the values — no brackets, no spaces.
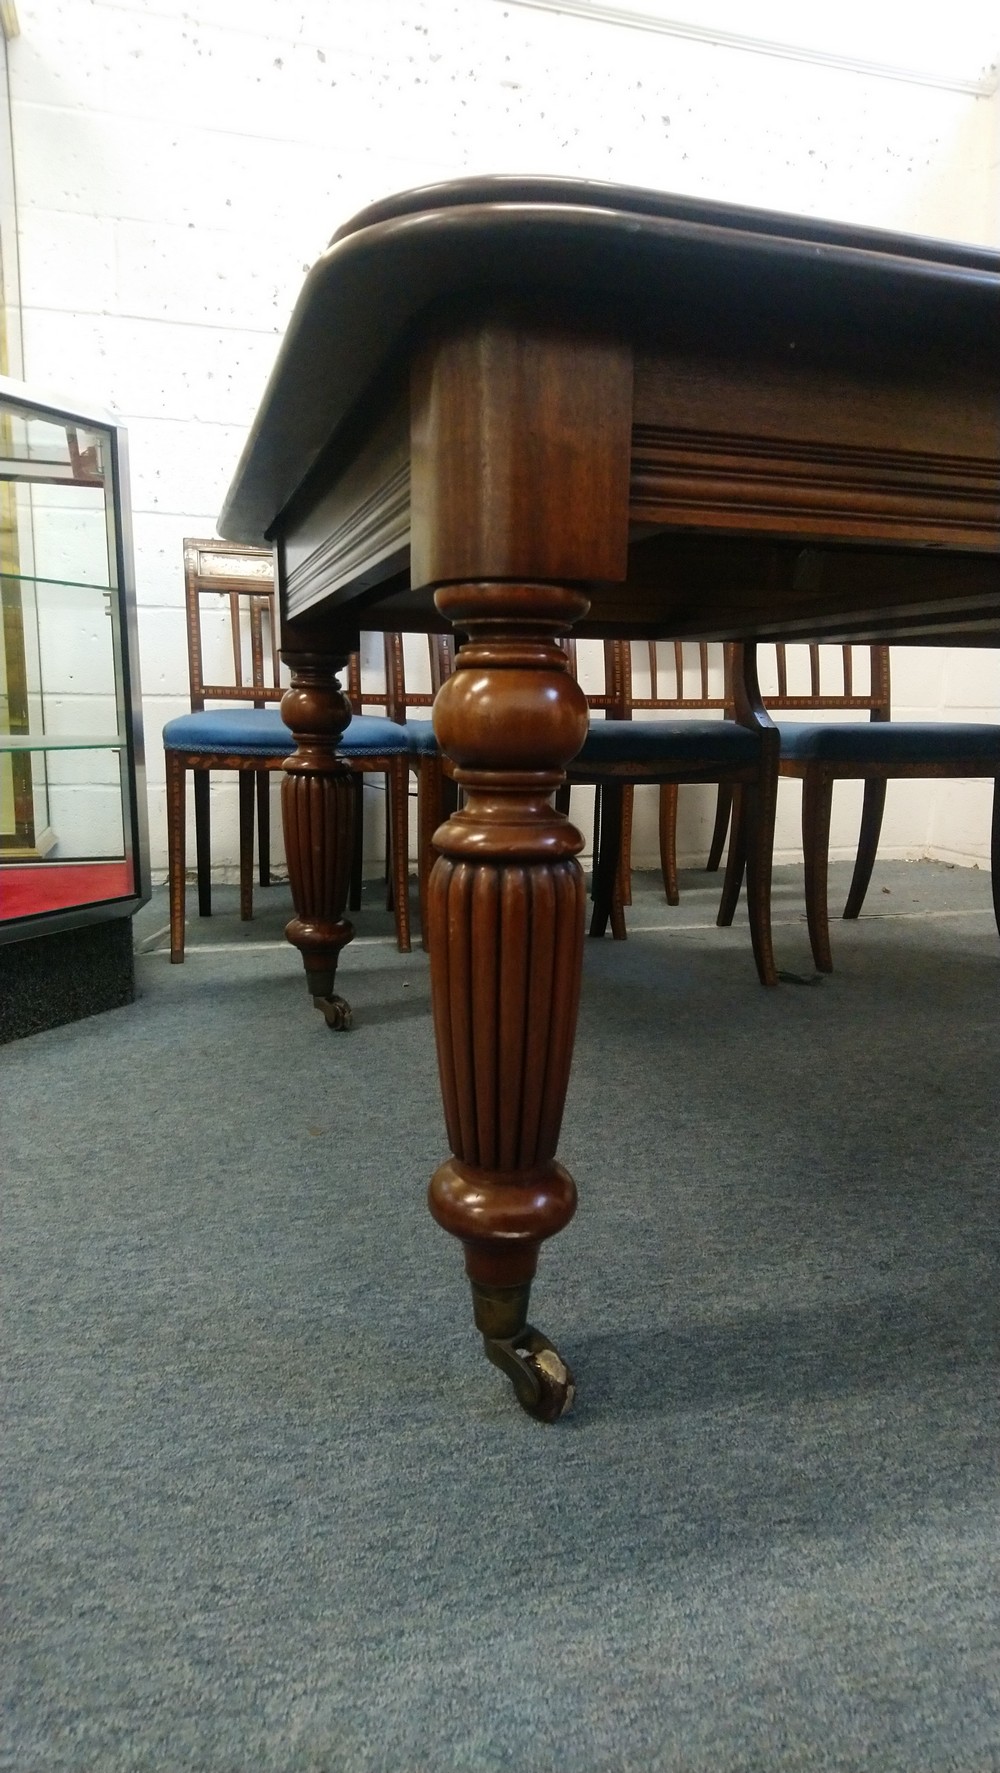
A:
218,176,1000,544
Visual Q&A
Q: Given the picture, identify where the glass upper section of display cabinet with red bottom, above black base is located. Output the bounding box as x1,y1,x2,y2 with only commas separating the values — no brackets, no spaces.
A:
0,383,142,926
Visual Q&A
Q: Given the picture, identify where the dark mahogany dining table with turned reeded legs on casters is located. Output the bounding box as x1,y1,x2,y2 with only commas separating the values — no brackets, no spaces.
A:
218,177,1000,1420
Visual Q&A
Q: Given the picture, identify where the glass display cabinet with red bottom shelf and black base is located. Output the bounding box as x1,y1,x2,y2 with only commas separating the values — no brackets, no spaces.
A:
0,376,149,1039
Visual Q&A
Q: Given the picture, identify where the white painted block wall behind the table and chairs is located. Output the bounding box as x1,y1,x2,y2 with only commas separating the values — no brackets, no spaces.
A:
9,0,1000,886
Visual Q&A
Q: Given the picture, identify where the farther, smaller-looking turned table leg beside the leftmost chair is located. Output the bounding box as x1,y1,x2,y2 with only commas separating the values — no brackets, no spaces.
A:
282,652,355,1028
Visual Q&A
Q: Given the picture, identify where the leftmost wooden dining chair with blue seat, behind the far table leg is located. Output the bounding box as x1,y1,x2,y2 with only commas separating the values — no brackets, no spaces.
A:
163,539,436,963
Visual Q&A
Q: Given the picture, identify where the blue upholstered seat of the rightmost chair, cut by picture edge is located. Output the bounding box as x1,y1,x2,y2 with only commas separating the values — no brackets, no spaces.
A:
780,720,1000,775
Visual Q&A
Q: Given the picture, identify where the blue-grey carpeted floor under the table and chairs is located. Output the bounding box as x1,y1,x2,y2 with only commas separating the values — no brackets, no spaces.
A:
0,863,1000,1773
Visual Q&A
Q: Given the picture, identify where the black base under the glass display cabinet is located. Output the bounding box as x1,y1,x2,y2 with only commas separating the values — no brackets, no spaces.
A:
0,917,135,1044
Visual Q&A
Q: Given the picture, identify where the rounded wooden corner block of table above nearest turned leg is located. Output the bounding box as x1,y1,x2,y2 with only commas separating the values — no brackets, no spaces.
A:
410,310,631,585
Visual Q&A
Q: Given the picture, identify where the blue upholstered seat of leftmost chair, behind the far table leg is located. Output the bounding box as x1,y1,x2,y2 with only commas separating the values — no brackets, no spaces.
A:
163,707,438,757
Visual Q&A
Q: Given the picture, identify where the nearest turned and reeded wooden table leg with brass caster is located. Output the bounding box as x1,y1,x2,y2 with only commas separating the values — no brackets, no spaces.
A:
427,583,587,1422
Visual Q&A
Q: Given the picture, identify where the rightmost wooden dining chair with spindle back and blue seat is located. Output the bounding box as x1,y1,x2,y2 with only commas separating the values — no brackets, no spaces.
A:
718,645,1000,973
